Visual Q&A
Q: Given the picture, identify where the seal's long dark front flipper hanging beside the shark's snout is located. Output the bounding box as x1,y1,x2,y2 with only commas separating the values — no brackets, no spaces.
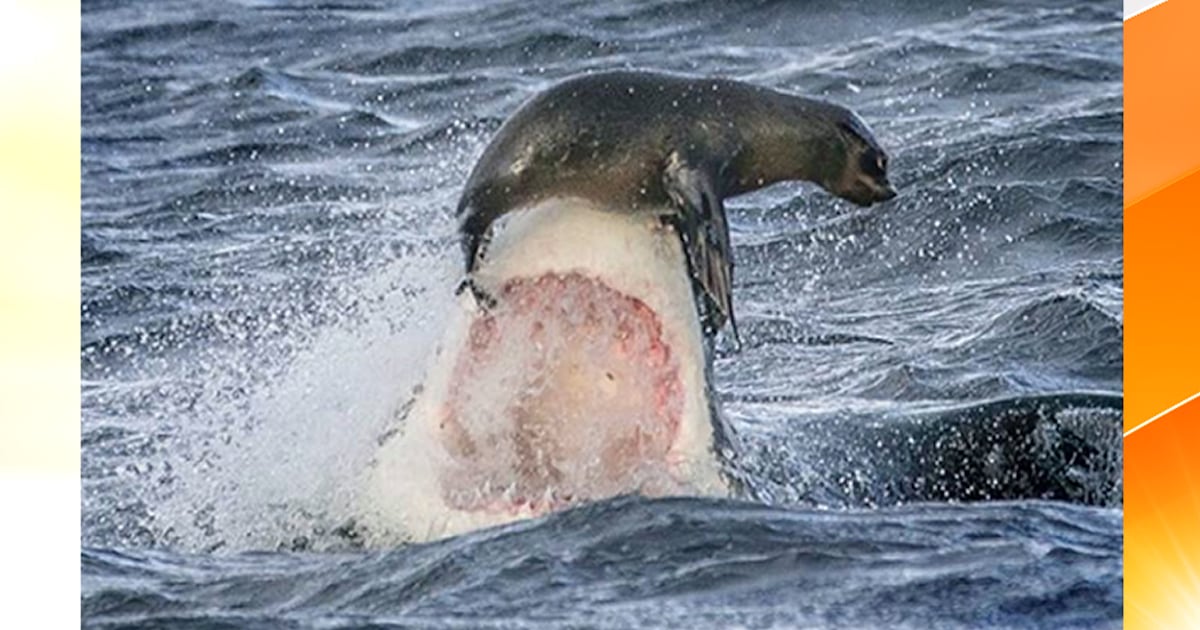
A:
662,152,742,348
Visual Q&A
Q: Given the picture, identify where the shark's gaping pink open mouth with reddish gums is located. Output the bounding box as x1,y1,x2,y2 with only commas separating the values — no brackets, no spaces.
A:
438,272,684,515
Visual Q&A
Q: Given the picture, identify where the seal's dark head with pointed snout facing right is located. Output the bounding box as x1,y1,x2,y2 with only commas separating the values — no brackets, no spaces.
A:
823,109,896,206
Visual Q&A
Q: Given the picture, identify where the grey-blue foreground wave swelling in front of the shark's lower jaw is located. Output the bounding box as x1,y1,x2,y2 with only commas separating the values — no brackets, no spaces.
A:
80,498,1121,628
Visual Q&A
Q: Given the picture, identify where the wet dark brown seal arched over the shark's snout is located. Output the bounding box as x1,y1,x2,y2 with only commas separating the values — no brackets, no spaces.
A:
457,72,896,336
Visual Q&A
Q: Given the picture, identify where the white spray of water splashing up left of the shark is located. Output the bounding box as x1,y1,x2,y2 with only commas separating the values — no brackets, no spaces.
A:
130,246,454,551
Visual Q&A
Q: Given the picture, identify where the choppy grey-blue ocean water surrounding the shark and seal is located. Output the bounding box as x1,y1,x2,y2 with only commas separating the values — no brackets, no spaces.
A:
80,0,1123,628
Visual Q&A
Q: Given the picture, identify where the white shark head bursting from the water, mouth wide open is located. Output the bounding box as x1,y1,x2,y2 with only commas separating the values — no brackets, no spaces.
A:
361,198,728,540
